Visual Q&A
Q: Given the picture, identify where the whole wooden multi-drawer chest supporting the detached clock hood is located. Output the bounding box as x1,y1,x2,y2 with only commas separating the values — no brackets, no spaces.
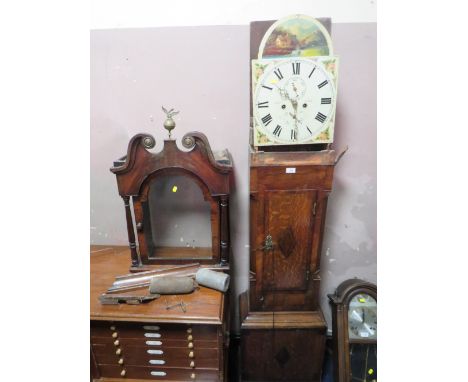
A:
90,246,228,382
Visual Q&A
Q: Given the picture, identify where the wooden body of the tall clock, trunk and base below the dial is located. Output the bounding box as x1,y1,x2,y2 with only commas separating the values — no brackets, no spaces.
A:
240,150,343,382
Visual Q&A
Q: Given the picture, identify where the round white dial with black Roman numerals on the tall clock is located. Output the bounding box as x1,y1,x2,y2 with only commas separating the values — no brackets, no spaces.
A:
253,58,336,144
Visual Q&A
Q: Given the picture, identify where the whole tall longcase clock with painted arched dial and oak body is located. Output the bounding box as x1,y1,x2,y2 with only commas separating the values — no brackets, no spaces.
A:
240,16,342,381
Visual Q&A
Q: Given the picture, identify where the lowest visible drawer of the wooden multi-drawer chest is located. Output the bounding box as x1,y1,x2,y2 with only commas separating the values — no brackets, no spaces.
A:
99,365,221,382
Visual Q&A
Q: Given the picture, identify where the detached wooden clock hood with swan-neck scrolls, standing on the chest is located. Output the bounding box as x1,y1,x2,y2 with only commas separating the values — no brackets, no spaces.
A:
110,132,233,271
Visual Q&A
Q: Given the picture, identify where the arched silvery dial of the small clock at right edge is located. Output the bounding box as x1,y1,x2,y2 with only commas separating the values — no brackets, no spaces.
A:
348,293,377,339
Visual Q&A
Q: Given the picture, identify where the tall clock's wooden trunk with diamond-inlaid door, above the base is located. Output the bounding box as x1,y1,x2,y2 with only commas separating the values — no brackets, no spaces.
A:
250,150,336,311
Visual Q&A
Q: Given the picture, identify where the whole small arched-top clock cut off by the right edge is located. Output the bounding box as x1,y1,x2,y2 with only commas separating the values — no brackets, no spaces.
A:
328,279,377,382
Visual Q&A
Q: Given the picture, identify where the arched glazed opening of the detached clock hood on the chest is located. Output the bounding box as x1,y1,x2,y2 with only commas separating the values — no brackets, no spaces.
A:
148,175,212,259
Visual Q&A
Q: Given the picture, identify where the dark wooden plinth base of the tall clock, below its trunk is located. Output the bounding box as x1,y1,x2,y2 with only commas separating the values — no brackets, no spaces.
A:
240,293,327,382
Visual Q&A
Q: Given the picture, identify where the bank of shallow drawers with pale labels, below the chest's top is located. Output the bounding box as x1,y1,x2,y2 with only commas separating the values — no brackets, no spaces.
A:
91,321,224,381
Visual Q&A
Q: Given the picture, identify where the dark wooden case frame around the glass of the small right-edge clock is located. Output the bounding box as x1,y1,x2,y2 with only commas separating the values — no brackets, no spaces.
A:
328,279,377,382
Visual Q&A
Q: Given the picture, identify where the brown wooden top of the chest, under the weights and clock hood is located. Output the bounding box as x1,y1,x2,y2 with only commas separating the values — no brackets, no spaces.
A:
90,246,224,325
